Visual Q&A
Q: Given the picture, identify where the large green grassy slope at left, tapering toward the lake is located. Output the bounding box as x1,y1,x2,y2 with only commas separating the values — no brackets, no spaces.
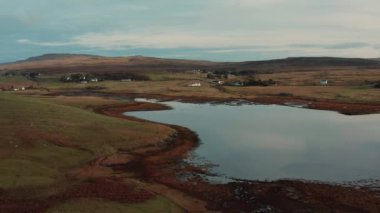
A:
0,93,172,189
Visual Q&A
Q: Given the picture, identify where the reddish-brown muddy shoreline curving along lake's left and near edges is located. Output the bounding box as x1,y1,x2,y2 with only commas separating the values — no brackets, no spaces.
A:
96,100,380,212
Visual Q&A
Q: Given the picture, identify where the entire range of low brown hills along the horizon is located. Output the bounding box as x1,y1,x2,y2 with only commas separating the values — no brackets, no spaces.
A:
0,54,380,73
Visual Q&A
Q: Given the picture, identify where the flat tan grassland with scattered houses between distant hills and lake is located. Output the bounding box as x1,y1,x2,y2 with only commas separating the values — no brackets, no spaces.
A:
0,69,380,104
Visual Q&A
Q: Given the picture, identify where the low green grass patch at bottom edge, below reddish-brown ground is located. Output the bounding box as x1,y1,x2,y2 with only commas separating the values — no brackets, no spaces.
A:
48,197,183,213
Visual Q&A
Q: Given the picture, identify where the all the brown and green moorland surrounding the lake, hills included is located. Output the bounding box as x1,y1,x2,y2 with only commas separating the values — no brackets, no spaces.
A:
0,54,380,212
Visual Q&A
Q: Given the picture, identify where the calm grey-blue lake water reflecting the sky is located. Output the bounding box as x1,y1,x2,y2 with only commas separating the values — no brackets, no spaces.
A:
127,102,380,181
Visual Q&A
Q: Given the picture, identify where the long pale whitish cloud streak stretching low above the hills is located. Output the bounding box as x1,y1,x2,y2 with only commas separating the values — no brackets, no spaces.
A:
17,28,374,52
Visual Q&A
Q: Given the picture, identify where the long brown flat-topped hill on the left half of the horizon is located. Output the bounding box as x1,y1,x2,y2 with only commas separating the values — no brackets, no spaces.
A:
0,54,215,73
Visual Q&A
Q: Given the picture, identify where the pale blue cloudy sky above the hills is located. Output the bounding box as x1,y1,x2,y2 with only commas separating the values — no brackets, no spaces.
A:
0,0,380,63
